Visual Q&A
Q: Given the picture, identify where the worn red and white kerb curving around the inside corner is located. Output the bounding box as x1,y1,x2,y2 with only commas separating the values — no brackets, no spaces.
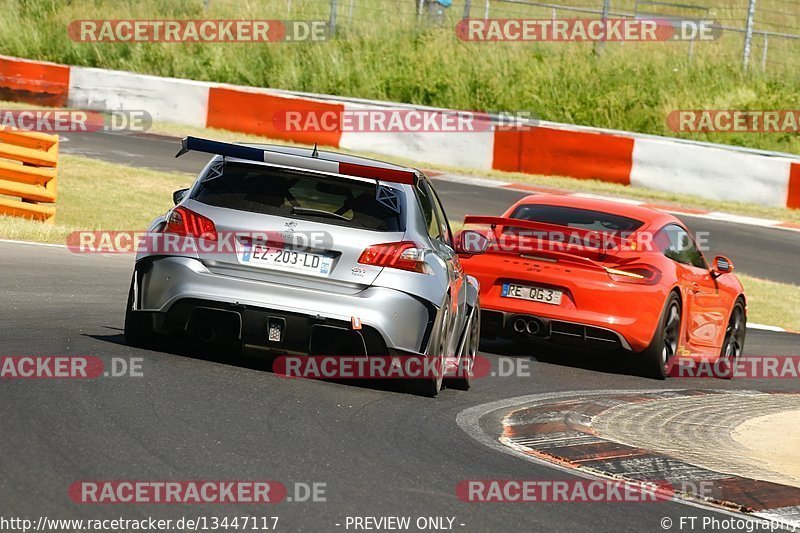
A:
456,390,800,531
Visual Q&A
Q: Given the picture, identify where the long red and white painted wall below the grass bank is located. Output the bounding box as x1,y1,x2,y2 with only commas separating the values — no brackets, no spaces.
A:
0,56,800,209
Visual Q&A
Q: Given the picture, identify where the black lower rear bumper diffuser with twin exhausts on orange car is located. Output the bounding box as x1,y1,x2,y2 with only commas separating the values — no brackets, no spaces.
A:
481,309,646,352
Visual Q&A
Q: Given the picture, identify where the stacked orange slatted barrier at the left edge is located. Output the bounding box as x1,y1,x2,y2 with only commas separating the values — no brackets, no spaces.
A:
0,128,58,223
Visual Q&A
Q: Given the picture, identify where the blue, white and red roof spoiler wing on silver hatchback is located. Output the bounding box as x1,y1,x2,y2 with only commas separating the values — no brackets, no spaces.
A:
175,137,417,185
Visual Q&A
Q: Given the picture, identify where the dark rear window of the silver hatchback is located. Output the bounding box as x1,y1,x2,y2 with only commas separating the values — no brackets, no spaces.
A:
193,163,405,231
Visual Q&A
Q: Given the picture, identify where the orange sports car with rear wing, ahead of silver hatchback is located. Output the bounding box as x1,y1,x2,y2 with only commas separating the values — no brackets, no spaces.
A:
459,195,747,378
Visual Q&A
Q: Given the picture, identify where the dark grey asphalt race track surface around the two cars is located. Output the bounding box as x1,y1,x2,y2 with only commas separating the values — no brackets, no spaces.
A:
0,134,800,532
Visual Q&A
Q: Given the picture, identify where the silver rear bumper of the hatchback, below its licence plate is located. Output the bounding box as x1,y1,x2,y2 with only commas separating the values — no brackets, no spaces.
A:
134,257,436,355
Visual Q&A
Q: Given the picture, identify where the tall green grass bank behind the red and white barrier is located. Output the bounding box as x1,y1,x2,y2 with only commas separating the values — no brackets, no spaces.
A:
0,0,800,153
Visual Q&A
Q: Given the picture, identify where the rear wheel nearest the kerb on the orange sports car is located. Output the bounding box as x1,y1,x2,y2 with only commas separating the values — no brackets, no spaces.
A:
636,292,683,379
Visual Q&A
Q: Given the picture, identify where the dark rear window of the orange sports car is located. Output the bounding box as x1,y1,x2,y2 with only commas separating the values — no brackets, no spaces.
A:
511,204,643,233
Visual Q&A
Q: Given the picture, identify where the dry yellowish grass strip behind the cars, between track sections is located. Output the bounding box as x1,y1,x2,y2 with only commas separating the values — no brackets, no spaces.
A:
0,155,800,331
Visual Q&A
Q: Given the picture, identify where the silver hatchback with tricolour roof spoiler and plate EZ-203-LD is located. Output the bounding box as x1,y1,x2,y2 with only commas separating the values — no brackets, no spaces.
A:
125,137,488,396
